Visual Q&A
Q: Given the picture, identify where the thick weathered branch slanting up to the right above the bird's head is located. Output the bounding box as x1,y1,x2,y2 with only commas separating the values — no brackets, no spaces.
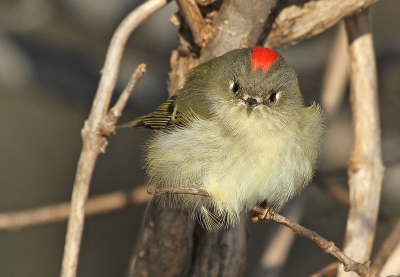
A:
262,0,378,48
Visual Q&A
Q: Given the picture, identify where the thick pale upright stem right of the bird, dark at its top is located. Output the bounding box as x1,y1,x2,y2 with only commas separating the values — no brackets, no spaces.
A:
338,9,384,276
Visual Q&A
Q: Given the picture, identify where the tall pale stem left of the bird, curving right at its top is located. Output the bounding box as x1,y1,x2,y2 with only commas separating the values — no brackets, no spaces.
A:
61,0,168,277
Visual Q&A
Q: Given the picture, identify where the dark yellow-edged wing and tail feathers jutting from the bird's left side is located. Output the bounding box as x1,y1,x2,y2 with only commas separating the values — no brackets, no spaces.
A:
121,96,184,129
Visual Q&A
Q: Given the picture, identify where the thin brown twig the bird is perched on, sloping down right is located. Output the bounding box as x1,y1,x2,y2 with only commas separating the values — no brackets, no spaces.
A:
151,188,379,277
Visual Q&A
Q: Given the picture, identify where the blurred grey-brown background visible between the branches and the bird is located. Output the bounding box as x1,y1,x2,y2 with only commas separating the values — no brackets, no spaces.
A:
0,0,400,277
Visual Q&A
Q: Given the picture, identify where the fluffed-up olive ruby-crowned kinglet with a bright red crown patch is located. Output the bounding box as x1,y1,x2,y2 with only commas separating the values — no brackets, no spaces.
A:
125,46,323,231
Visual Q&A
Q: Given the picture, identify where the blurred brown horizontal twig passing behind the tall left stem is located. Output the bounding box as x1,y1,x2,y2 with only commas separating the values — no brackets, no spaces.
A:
0,186,151,231
